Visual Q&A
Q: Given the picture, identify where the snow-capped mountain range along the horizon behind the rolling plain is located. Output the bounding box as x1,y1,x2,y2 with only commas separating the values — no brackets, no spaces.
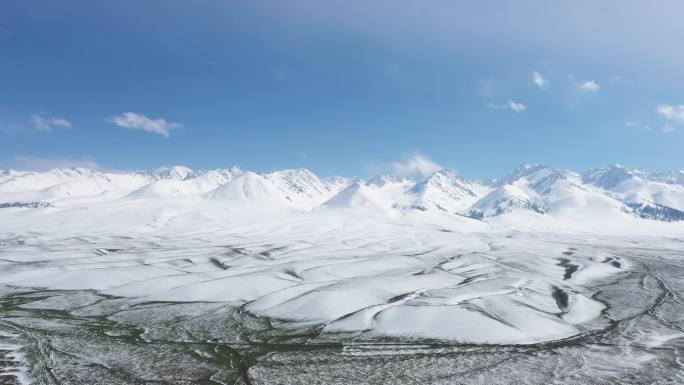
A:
0,164,684,222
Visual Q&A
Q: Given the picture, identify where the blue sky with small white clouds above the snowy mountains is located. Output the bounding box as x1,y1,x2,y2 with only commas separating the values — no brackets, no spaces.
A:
0,0,684,177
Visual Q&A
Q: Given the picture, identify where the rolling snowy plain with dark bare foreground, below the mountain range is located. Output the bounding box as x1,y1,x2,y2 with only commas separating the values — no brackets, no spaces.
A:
0,166,684,384
